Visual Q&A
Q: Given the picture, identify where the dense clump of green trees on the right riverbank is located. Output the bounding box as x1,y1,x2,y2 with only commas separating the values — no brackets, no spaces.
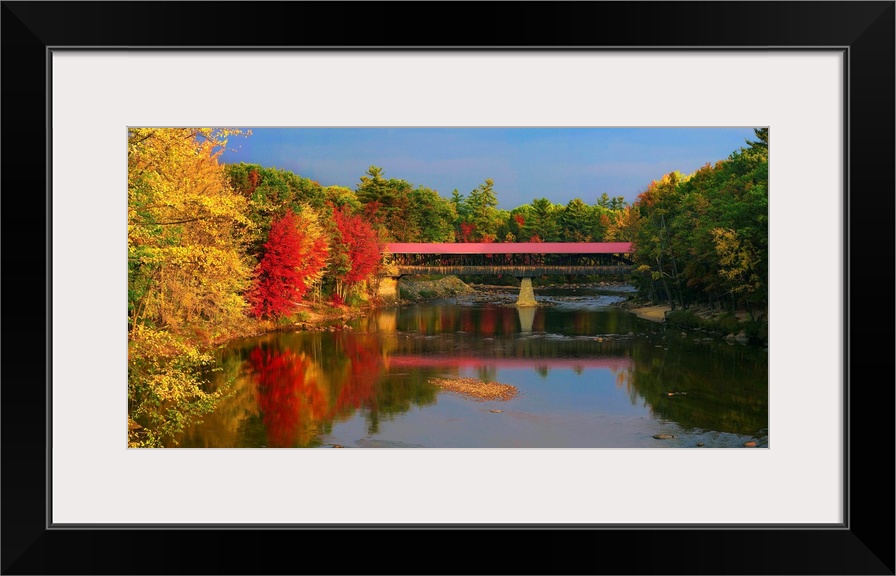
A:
632,128,768,315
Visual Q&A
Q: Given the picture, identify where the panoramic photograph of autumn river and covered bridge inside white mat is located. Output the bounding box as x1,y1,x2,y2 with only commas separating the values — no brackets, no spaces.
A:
127,127,769,448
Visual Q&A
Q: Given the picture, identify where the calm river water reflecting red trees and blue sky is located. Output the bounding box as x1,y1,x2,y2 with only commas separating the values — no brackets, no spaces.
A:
173,289,768,448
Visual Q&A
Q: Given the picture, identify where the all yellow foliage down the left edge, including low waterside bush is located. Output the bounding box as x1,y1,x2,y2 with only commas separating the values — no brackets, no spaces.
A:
128,128,251,447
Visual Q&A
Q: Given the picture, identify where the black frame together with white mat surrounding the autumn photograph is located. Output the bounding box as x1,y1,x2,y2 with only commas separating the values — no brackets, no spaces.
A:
2,2,896,574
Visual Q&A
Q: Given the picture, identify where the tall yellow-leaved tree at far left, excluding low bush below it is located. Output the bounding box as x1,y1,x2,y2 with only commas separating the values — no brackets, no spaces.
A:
128,128,251,339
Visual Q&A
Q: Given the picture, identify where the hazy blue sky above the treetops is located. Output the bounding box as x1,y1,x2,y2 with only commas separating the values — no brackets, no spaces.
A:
221,127,754,210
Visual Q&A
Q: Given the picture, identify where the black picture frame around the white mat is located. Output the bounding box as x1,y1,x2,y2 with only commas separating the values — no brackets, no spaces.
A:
0,1,896,574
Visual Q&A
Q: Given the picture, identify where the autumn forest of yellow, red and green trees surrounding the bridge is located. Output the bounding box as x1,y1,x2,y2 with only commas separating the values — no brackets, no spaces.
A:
128,128,769,447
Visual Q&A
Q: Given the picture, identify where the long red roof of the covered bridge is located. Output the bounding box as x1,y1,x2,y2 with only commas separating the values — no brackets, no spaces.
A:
386,242,632,254
